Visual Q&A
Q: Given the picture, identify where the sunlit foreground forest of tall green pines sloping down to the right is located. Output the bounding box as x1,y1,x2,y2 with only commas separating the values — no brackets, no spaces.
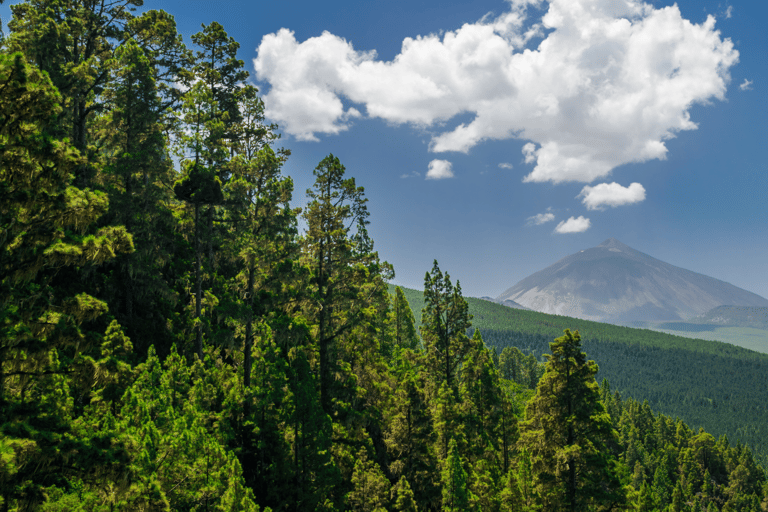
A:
0,0,768,512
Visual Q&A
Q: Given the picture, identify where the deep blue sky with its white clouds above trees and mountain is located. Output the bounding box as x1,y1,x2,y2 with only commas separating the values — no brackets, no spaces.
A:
0,0,768,297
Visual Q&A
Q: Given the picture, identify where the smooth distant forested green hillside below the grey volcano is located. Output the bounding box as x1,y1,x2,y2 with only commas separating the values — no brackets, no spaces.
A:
390,285,768,467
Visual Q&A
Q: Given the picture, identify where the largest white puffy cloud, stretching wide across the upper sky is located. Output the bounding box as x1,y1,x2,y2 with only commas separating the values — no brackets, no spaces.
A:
254,0,738,183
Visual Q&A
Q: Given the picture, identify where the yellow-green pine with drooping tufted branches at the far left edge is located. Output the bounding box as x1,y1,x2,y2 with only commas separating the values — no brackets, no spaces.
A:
0,53,133,507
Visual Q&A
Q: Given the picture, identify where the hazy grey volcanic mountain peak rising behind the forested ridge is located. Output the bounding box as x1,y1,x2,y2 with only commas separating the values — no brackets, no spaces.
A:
495,238,768,324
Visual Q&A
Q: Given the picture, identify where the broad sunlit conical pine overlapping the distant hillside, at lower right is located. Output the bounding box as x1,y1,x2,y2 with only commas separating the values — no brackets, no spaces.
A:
520,330,625,511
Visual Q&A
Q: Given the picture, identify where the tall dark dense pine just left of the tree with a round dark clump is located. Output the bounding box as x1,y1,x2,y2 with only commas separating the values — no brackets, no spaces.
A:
93,39,175,354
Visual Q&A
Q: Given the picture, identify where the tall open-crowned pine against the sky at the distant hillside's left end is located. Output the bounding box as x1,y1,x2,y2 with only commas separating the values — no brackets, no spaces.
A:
303,155,394,414
